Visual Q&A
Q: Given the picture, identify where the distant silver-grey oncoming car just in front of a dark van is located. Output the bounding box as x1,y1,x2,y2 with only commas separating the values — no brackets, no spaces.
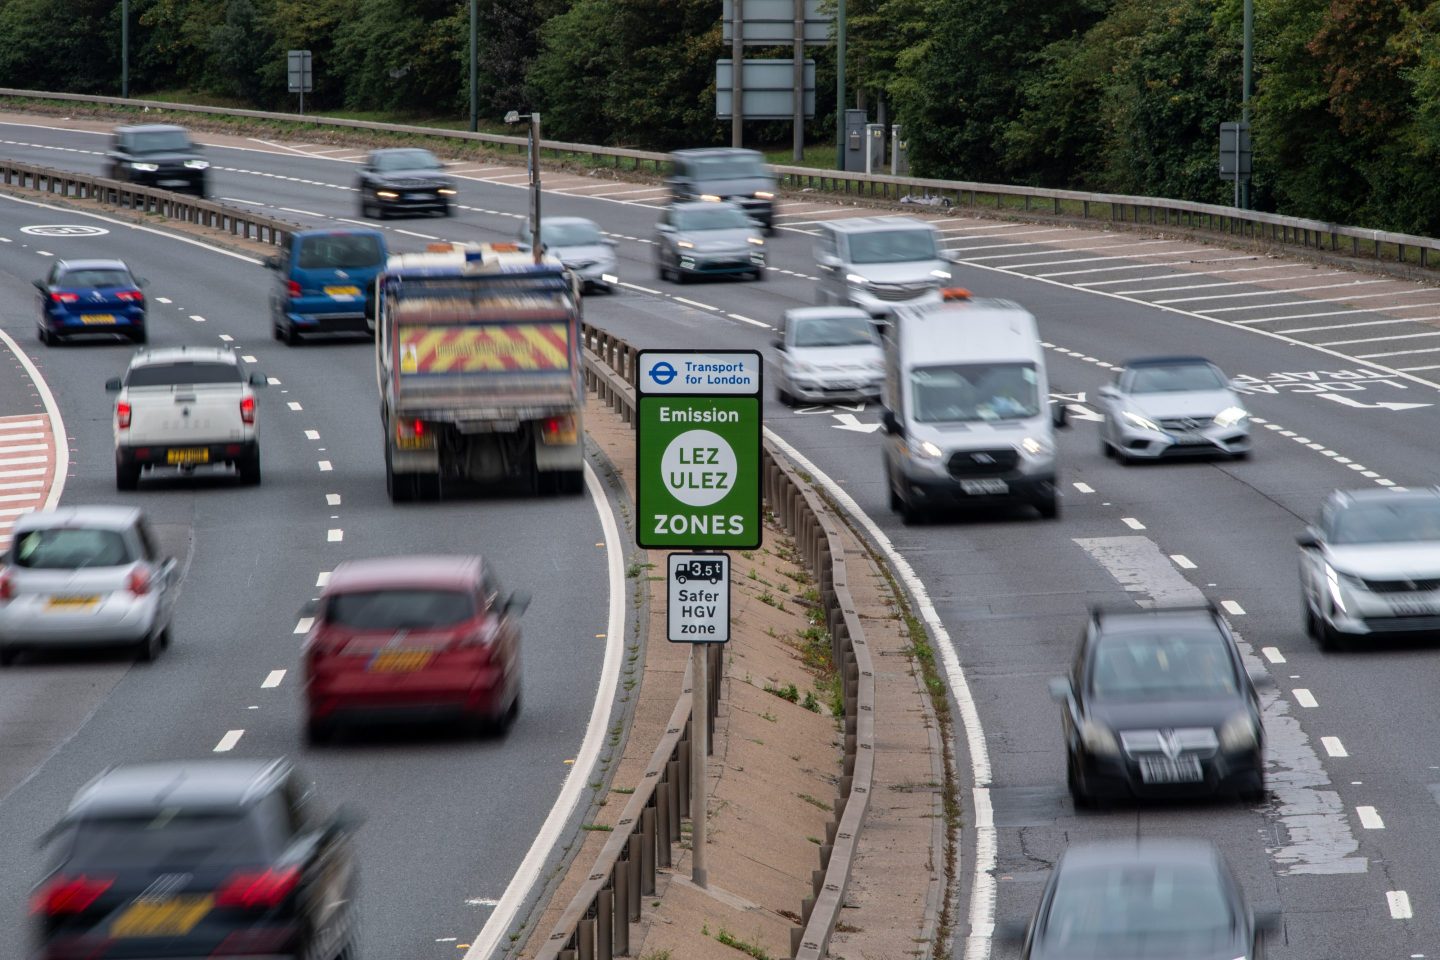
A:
655,200,765,284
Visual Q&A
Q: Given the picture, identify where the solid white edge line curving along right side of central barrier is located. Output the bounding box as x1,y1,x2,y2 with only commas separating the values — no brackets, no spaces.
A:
760,427,996,960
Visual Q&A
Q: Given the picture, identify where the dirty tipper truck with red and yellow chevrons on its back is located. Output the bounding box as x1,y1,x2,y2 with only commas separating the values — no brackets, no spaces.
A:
374,243,585,502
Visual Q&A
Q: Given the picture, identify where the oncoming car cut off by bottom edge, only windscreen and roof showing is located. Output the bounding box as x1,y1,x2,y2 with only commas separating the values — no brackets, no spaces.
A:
999,841,1280,960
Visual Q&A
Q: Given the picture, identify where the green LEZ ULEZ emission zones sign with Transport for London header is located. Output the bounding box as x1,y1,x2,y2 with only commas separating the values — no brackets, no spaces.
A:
635,351,762,550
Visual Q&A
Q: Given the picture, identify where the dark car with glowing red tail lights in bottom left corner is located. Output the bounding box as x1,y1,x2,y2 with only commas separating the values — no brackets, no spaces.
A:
30,760,360,960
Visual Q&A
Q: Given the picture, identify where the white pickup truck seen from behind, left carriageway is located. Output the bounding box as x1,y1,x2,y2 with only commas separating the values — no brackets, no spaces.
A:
105,347,265,489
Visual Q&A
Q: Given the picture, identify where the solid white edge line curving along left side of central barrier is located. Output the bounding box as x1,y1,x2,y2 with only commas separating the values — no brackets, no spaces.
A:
464,463,626,960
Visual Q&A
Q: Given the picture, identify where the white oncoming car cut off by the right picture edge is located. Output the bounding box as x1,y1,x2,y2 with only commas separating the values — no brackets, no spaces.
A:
1297,486,1440,649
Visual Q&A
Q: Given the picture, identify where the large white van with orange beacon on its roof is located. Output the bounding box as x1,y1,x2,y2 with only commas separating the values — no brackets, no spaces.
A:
881,289,1066,524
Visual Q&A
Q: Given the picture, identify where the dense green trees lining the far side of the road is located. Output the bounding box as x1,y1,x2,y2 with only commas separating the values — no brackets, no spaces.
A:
0,0,1440,235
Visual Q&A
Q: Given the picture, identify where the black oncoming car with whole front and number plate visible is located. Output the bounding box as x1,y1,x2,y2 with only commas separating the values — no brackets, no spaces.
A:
1050,606,1270,806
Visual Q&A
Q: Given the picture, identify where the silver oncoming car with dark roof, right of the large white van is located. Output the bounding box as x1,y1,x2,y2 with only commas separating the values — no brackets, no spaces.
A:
1097,357,1250,463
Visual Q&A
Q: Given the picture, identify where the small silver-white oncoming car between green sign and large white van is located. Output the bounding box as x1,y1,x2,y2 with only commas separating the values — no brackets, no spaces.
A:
773,307,886,406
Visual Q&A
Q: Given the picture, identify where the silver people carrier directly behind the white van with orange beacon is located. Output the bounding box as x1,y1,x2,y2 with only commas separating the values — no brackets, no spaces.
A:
815,217,950,320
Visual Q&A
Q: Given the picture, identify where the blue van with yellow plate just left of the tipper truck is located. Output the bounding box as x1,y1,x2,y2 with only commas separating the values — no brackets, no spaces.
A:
265,229,387,345
